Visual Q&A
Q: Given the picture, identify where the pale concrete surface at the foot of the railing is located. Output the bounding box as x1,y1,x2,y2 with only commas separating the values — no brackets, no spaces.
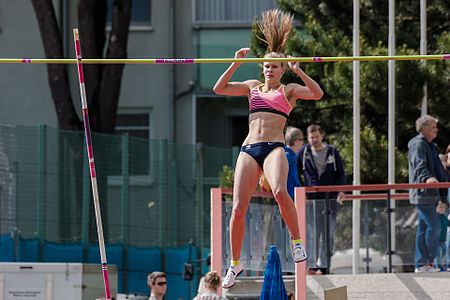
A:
224,272,450,300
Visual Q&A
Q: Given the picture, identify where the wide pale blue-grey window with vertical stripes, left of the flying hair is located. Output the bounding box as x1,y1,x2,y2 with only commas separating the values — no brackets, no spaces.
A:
192,0,277,26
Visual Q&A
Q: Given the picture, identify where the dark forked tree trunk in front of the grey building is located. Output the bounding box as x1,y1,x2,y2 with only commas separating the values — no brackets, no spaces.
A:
32,0,131,133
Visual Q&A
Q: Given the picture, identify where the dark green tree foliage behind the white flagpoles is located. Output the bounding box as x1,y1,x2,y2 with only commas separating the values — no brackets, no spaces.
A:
252,0,450,183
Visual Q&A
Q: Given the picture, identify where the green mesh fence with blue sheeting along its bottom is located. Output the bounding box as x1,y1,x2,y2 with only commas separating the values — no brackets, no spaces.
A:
0,125,237,292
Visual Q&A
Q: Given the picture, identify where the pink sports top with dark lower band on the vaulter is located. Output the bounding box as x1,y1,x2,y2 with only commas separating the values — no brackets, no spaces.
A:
249,84,292,119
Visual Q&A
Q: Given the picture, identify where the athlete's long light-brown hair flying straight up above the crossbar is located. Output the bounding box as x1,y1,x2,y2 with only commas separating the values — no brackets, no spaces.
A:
256,9,294,57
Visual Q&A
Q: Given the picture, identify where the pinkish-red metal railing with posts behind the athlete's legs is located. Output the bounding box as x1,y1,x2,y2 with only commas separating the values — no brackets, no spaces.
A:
211,183,450,300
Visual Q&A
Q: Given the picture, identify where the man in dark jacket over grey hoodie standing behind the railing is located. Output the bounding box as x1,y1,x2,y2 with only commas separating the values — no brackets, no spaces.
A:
298,125,346,274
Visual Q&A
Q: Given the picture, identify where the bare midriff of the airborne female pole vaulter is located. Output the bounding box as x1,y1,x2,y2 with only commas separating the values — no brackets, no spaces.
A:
243,112,286,145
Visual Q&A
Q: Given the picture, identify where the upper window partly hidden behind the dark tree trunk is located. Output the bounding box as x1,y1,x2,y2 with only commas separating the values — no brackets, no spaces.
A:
107,0,152,29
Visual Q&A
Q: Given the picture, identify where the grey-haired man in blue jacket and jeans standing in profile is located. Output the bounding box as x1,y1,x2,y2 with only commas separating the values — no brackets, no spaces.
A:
408,115,447,273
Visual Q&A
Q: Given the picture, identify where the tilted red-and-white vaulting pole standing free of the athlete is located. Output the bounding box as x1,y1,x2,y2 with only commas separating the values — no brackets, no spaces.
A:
73,28,111,300
